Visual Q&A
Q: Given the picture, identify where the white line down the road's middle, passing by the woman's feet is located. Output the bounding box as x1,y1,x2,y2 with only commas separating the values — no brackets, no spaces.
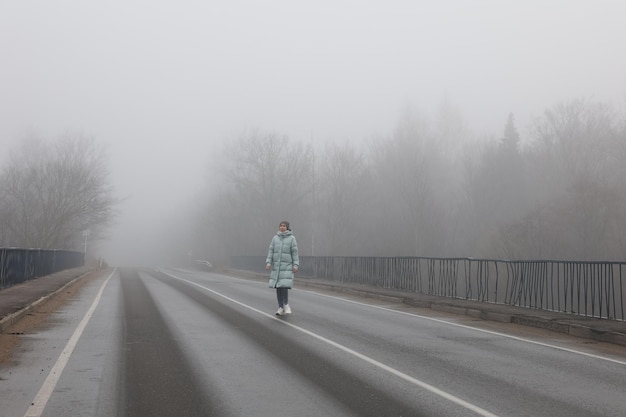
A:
161,271,498,417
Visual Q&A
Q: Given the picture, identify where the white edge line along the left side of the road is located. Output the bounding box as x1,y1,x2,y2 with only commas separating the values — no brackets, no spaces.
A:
24,268,117,417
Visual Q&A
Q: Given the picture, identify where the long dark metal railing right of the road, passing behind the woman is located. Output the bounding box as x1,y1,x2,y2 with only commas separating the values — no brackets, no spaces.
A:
230,256,626,321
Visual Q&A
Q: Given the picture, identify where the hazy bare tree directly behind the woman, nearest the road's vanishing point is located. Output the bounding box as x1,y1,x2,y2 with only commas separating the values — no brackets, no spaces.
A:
202,130,313,254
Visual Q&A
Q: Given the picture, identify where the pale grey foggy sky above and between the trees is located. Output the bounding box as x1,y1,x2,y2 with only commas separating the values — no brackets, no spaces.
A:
0,0,626,264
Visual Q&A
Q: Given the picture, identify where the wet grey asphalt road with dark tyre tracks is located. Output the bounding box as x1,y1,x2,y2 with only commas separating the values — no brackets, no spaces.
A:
0,269,626,417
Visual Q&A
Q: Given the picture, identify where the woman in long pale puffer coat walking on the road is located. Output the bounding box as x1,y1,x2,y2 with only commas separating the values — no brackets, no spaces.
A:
265,222,300,316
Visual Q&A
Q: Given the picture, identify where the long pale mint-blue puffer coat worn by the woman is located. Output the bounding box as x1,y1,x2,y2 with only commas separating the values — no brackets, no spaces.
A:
265,230,300,288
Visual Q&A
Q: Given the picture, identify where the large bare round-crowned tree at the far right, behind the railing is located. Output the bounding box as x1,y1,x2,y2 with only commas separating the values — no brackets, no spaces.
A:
508,100,626,260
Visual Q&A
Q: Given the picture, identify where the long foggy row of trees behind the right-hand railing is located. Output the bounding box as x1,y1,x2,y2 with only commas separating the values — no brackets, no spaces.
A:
190,99,626,260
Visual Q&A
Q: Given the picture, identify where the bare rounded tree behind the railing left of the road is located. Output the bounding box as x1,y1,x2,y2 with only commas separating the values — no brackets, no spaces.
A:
0,133,118,250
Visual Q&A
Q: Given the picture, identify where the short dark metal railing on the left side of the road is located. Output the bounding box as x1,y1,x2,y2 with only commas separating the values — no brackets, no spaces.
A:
0,248,85,289
